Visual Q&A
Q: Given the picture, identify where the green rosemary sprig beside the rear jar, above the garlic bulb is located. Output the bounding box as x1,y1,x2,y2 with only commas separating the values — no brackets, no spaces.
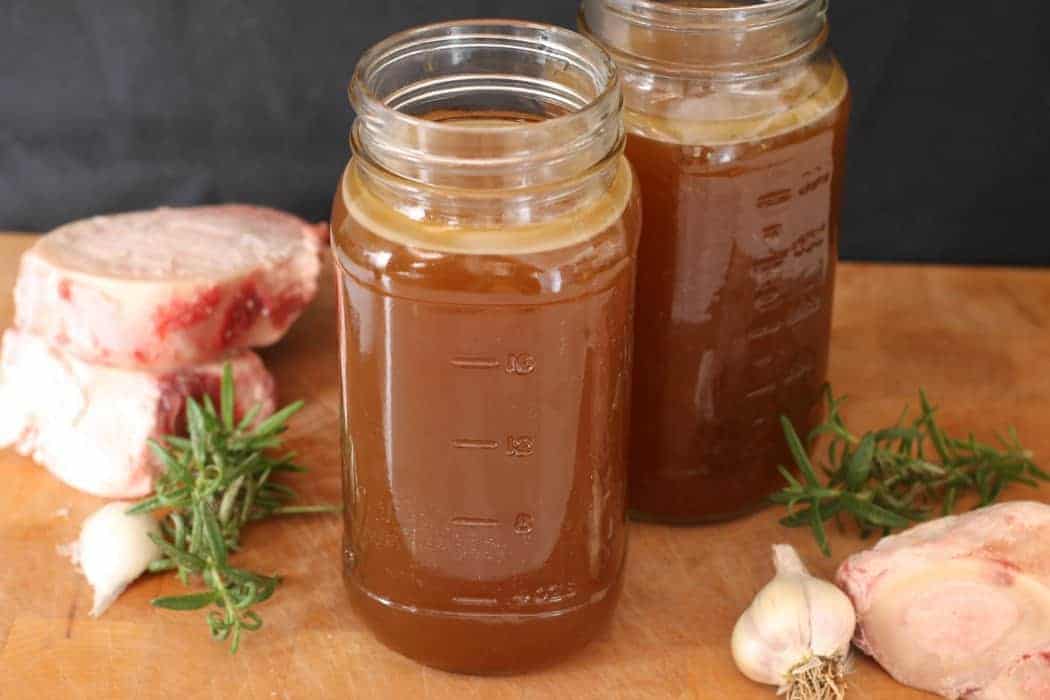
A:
772,386,1050,556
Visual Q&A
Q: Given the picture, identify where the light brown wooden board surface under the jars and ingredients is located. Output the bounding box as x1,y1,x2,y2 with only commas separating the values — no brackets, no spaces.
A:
0,234,1050,700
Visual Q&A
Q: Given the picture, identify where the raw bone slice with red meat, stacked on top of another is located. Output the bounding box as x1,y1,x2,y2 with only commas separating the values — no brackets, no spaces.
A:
15,205,321,369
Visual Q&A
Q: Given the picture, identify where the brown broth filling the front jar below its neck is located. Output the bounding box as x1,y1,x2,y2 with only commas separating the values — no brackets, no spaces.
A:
333,156,641,673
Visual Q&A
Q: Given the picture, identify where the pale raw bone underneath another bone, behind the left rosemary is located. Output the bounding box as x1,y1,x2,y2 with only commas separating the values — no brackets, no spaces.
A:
0,330,275,499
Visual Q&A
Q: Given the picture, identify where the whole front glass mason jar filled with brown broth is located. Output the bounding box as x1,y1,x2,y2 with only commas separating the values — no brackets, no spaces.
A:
332,21,641,673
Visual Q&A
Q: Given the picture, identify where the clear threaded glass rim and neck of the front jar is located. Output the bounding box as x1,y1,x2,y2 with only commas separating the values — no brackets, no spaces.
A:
349,19,623,190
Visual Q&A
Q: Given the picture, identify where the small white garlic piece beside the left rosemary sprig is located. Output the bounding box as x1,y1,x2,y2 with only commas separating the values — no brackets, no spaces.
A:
69,502,161,617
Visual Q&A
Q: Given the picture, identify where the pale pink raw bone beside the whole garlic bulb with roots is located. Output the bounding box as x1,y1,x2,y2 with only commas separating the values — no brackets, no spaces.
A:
838,502,1050,700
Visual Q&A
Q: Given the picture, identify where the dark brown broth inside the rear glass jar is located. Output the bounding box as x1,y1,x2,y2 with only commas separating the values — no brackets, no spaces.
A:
627,61,848,523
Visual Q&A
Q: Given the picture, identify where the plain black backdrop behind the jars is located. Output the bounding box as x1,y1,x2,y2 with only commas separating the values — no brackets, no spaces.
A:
0,0,1050,264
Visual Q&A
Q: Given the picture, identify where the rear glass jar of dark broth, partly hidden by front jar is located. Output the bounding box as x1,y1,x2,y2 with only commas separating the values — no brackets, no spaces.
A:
581,0,849,523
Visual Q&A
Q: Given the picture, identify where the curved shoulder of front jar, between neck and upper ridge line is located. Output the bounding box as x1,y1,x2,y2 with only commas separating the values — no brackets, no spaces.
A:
332,157,642,305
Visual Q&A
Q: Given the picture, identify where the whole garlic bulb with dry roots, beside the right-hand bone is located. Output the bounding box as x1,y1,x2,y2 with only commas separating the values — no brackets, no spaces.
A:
732,545,857,700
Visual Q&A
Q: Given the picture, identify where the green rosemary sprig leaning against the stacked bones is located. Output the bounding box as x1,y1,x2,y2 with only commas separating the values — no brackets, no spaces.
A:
128,363,338,653
